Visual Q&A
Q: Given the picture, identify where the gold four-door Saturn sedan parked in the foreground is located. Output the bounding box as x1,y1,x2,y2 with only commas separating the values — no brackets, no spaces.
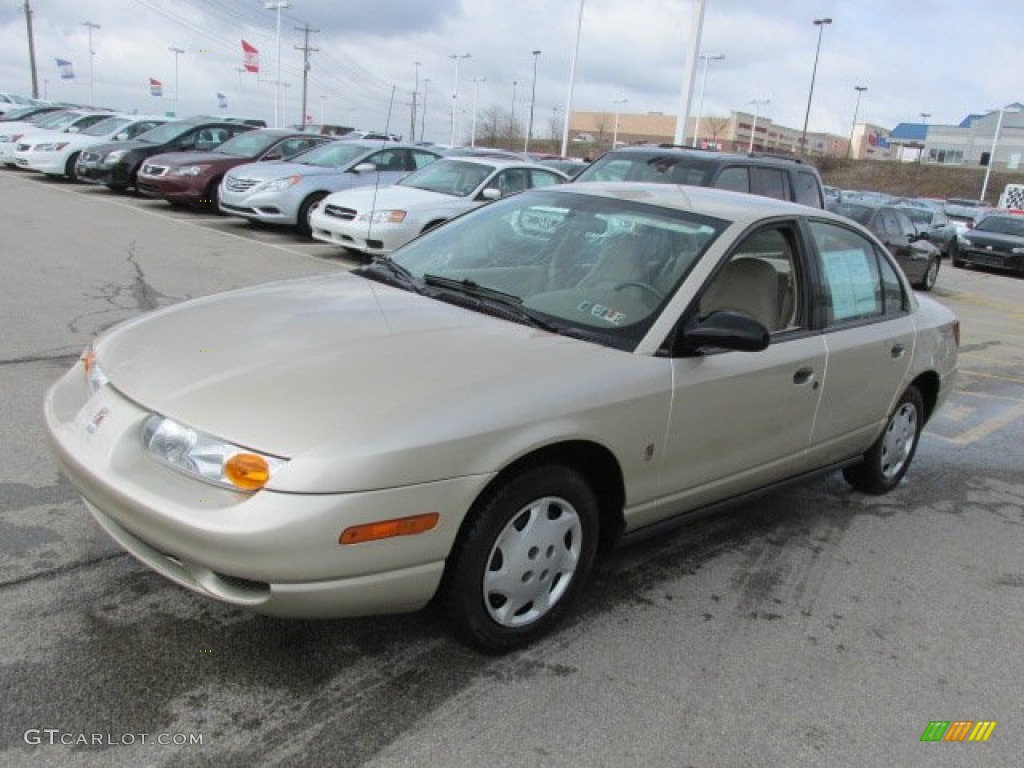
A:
45,182,959,651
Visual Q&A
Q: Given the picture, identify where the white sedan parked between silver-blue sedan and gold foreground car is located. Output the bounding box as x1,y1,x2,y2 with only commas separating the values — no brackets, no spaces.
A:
309,157,568,256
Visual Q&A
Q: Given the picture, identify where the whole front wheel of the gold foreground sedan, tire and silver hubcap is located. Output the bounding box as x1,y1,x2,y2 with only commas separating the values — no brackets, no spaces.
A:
438,465,599,653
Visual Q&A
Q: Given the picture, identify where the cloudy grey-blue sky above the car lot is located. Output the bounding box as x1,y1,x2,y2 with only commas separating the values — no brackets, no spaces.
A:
0,0,1024,141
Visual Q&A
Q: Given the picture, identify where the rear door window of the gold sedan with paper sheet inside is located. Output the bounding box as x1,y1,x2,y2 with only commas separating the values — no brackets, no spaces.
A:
810,221,907,326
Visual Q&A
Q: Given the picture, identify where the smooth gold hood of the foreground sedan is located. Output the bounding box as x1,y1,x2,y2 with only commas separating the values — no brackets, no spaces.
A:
96,273,643,468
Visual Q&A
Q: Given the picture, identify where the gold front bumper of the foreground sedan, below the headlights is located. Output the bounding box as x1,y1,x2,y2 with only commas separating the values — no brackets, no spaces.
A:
45,365,489,617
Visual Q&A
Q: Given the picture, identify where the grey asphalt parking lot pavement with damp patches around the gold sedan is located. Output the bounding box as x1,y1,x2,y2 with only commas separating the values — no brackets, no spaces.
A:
0,172,1024,768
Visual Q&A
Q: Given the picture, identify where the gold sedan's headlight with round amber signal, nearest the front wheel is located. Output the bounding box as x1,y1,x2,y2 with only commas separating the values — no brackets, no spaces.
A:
142,414,286,490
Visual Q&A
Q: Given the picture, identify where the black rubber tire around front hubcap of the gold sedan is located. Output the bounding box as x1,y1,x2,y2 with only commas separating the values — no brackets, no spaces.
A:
440,465,599,653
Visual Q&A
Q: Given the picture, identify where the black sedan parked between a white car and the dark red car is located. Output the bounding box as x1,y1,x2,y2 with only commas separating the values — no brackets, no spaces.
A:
75,118,254,190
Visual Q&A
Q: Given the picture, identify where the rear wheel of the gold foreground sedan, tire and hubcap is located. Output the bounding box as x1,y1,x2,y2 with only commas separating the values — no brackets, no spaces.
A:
843,387,925,496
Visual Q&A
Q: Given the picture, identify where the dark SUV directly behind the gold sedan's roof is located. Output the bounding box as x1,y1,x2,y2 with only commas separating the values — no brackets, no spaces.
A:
575,144,825,208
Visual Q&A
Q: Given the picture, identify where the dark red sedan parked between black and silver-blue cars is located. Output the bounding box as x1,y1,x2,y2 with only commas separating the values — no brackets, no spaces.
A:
137,128,332,210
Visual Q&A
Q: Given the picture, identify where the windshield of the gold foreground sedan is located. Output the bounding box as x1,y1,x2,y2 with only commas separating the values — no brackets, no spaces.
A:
385,187,728,349
